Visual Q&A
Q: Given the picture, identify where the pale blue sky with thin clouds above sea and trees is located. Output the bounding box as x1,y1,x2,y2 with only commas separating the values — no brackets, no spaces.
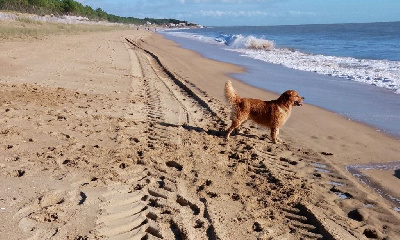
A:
76,0,400,26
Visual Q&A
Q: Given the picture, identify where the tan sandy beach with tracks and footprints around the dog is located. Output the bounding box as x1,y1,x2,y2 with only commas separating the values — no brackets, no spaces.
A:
0,25,400,240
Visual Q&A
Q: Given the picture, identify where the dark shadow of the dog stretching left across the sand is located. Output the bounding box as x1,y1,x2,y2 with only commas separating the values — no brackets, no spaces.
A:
158,122,271,141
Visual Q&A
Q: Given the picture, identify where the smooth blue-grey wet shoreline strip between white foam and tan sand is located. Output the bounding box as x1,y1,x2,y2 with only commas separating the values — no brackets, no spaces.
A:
161,31,400,140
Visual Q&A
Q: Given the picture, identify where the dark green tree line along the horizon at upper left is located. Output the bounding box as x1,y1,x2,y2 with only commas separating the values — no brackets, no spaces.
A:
0,0,190,25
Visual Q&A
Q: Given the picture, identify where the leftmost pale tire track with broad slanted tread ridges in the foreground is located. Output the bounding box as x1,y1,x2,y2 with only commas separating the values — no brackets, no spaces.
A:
93,39,157,239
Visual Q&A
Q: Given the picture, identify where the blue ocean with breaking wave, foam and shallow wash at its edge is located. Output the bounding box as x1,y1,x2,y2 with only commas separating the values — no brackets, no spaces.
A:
160,22,400,139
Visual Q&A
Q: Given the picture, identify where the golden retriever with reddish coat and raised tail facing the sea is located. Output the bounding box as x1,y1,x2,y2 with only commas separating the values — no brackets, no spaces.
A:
225,81,304,143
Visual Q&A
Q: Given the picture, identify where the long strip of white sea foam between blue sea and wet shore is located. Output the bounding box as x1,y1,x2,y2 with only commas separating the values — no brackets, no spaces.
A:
231,48,400,94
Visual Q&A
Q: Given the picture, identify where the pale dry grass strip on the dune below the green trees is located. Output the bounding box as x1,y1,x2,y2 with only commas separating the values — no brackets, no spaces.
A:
0,17,129,39
